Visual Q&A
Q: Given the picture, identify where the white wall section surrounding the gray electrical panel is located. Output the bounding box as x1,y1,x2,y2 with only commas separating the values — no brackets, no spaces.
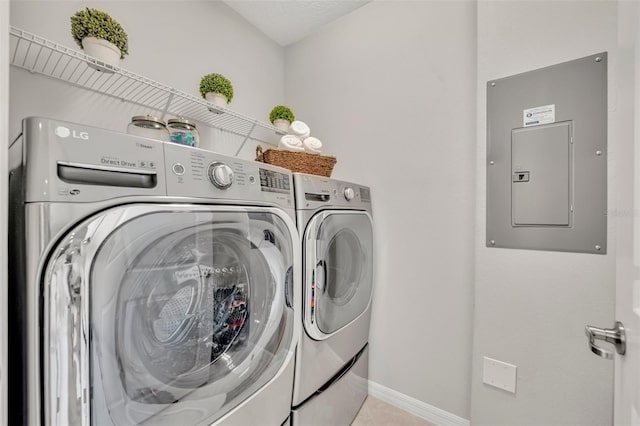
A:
471,1,625,425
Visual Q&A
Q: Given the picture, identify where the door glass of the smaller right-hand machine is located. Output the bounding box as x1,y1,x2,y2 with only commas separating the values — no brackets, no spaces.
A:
314,212,373,334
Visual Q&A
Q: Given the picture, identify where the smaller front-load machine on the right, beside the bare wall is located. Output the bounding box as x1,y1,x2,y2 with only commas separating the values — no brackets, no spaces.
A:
291,173,374,426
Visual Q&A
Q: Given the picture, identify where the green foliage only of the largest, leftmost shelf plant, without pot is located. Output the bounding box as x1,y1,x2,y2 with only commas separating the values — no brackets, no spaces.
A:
71,7,129,59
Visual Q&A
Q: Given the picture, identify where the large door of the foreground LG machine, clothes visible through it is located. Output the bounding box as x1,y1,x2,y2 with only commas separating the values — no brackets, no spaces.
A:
42,206,294,425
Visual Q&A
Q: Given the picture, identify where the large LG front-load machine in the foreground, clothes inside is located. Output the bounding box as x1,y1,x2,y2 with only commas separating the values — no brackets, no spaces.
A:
8,118,301,426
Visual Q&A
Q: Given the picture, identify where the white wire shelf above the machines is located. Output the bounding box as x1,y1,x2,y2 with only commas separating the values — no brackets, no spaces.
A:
10,27,284,152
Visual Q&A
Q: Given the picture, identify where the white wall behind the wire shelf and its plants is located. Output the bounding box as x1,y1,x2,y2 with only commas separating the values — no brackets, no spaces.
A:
11,0,284,159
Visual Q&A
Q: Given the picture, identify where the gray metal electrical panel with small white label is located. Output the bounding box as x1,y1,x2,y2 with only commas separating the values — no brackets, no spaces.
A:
487,52,607,254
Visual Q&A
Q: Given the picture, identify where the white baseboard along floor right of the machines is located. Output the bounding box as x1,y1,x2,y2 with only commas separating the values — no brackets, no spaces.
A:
369,380,471,426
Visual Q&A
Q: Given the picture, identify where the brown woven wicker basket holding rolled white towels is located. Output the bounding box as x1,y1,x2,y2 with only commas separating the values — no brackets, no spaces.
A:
256,145,337,177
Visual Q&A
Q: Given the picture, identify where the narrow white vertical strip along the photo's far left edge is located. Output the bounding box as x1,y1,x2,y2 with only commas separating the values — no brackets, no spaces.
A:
0,0,9,424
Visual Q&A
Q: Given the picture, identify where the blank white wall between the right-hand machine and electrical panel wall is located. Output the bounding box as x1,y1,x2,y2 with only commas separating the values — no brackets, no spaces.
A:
285,1,476,418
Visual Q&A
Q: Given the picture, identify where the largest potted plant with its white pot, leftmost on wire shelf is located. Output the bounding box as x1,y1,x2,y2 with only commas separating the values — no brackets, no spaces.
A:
71,7,129,66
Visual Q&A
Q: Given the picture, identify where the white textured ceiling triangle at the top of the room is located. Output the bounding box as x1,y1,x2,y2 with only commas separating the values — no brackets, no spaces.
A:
224,0,371,46
